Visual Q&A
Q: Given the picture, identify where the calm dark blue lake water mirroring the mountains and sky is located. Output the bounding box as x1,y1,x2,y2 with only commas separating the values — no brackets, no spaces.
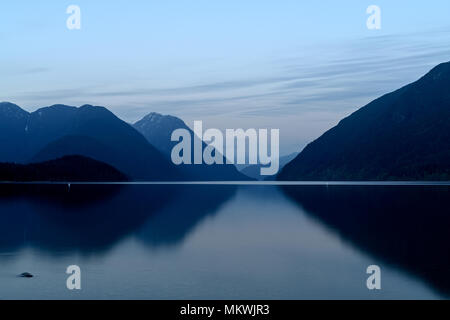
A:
0,185,450,299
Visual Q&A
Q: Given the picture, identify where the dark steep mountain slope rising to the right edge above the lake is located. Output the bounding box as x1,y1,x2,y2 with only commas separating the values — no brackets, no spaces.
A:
278,62,450,180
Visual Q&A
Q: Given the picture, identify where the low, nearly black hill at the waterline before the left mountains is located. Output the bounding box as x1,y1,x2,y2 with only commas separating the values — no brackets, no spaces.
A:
0,156,127,182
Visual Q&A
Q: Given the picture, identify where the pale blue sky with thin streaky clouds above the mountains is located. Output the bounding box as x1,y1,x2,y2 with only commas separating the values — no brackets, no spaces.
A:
0,0,450,154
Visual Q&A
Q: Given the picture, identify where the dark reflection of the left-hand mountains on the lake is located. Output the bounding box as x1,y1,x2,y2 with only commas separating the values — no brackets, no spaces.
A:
0,185,235,253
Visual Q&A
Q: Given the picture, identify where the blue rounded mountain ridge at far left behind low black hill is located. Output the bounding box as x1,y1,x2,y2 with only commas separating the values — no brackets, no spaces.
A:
0,103,180,180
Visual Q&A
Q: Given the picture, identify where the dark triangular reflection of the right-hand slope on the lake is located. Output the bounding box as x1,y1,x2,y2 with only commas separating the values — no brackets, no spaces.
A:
285,186,450,295
